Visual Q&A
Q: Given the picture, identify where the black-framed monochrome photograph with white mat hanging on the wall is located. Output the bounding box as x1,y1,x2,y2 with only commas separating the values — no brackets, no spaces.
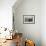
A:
23,15,35,24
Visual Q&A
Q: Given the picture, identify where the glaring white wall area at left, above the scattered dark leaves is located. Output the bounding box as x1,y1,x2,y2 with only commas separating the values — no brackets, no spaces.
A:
0,0,16,29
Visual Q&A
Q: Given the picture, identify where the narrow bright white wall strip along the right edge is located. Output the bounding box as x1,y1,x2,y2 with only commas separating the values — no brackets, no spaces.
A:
41,0,46,46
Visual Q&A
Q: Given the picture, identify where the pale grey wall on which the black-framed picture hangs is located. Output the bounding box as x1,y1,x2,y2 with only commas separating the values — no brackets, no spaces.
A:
13,0,41,46
